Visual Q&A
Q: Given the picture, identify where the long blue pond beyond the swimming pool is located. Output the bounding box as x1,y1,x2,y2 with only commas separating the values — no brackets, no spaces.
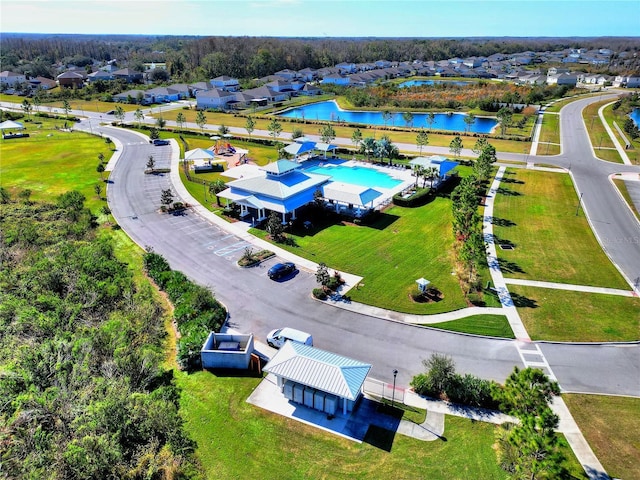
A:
279,100,498,133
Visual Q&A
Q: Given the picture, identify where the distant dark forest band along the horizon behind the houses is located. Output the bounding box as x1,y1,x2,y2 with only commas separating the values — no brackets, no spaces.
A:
0,34,638,82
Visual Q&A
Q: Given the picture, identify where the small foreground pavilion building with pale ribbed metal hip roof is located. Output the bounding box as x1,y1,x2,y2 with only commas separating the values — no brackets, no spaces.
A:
264,341,371,415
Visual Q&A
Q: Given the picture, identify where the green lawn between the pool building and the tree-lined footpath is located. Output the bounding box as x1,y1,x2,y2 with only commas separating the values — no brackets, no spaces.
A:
251,192,467,314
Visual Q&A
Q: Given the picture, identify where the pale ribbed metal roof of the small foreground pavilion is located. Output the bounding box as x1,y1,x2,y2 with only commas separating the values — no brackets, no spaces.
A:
264,341,371,400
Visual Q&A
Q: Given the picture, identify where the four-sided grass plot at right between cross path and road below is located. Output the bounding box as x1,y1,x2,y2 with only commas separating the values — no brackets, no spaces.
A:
508,285,640,342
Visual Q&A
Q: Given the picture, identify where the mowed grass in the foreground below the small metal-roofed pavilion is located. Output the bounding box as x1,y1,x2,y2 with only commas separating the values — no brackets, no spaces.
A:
176,372,506,480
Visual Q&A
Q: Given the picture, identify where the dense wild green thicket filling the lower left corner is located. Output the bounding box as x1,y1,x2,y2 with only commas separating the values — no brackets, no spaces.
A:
0,193,198,479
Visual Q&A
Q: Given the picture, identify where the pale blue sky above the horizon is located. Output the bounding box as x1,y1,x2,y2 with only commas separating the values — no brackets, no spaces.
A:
0,0,640,37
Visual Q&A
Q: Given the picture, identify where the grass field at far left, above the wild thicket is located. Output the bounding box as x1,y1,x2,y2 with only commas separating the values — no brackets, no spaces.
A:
0,117,113,214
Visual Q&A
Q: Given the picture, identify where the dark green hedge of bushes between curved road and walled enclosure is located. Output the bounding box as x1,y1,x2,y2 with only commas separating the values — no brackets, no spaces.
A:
144,252,227,370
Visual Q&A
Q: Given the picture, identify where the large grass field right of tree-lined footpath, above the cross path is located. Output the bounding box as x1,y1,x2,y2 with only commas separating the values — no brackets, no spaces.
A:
493,169,629,289
